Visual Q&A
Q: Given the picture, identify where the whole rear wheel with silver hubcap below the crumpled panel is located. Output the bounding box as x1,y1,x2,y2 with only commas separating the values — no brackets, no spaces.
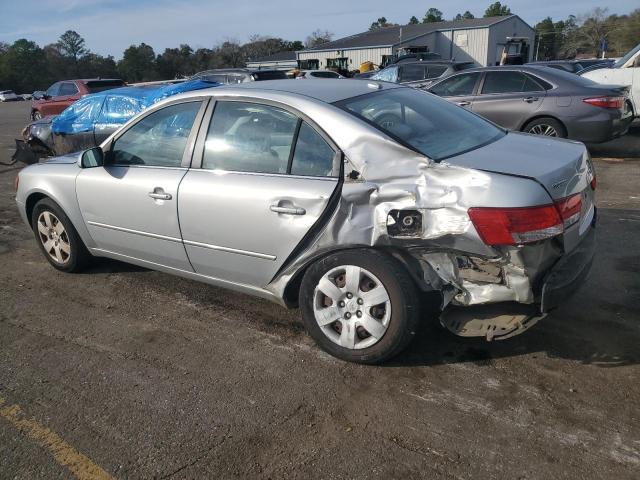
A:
300,250,420,364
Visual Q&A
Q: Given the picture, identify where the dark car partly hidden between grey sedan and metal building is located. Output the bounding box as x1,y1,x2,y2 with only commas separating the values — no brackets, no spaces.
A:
370,60,474,87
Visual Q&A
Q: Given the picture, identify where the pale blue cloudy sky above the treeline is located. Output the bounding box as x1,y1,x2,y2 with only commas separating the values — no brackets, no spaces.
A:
0,0,640,59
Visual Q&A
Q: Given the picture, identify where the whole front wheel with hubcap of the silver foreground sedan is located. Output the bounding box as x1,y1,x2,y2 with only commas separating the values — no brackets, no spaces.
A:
31,198,91,273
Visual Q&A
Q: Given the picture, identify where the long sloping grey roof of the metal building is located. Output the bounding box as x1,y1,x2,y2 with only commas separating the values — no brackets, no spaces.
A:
302,15,517,52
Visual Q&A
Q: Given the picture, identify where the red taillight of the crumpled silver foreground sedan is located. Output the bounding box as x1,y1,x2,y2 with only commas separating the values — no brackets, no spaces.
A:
469,194,582,245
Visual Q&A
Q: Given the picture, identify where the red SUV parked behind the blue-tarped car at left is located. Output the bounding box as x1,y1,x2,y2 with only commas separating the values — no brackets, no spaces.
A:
31,78,126,120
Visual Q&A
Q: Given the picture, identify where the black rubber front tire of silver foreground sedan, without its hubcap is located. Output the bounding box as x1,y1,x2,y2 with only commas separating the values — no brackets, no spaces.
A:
31,198,93,273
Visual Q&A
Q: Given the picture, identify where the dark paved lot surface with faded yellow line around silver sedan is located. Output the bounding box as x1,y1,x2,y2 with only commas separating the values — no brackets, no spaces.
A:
0,102,640,480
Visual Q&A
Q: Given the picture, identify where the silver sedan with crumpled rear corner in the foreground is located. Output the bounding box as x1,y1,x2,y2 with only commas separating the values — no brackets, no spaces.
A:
16,80,596,363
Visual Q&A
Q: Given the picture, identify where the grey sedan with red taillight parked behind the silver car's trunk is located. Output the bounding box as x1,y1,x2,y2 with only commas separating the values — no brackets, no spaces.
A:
428,66,632,143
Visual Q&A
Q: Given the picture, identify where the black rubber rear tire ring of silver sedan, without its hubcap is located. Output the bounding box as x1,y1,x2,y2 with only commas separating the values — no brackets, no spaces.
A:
299,249,421,365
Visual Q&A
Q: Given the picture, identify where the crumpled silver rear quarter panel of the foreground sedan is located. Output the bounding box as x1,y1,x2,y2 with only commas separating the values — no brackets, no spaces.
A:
267,94,551,307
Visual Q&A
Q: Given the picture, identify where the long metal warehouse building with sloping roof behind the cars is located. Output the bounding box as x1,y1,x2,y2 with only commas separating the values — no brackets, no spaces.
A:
296,15,535,70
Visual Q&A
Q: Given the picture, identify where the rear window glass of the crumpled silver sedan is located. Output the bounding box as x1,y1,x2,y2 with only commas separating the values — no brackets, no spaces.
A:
337,88,505,161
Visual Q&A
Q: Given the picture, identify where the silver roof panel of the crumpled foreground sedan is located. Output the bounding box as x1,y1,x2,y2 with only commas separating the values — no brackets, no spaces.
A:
181,78,408,103
